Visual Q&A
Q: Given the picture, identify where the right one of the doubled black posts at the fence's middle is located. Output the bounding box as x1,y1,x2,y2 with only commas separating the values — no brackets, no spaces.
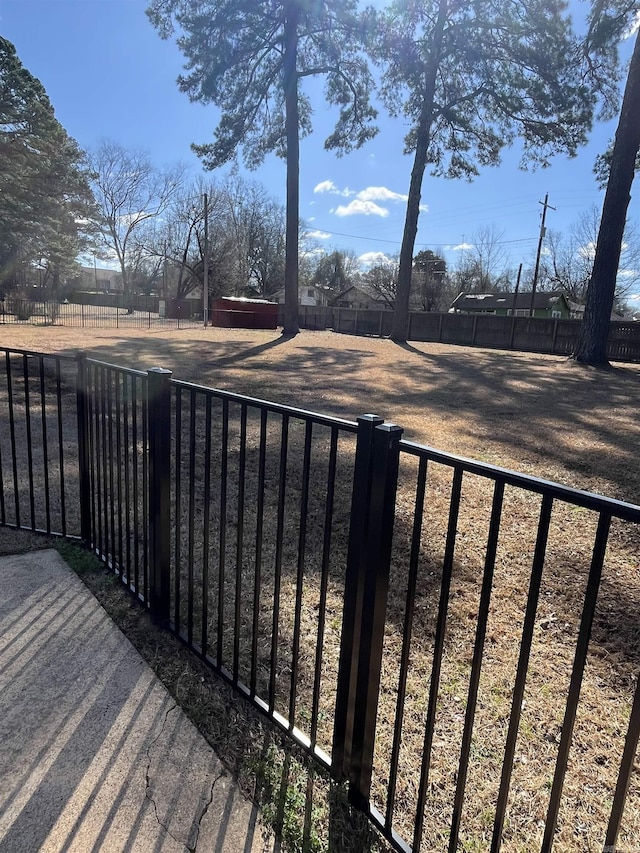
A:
349,424,403,811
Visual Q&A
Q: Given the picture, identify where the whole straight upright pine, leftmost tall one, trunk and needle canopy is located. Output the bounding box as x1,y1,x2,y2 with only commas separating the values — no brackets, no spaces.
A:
147,0,376,334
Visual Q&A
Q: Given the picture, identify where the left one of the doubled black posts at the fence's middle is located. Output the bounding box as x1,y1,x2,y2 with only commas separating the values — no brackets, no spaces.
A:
331,415,383,779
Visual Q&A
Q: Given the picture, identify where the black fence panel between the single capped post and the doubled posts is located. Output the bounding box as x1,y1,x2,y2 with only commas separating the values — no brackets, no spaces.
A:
171,381,356,765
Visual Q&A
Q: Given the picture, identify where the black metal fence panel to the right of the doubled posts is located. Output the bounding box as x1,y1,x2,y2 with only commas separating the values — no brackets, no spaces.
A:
350,440,640,851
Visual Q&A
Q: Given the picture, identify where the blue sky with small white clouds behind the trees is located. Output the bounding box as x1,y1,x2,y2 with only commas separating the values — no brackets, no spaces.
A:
0,0,640,286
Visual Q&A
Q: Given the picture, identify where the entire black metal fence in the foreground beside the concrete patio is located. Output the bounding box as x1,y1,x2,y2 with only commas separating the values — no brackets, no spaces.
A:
0,342,640,851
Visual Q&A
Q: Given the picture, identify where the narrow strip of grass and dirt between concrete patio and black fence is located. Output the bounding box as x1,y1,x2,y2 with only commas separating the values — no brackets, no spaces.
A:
71,545,387,853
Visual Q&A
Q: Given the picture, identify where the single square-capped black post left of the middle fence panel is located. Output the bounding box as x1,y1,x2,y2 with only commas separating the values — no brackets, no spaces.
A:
147,367,172,625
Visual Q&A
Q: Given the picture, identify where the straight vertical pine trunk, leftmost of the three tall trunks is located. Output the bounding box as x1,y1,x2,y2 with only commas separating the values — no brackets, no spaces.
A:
282,5,300,335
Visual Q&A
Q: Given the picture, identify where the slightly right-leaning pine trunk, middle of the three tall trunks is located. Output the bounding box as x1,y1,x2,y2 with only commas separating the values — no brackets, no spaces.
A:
391,0,449,343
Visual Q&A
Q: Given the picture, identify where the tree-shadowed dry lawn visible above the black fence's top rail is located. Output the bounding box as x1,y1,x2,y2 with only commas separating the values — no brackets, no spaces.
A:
40,332,640,502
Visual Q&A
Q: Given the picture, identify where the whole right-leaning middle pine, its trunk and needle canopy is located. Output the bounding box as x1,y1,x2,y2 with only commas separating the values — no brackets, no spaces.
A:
371,0,596,340
